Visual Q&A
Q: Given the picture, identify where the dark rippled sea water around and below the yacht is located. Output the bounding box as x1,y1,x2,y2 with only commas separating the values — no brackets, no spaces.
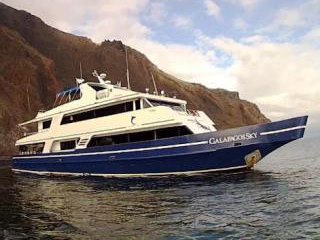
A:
0,138,320,240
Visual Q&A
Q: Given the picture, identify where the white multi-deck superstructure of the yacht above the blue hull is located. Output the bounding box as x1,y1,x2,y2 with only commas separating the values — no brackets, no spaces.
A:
16,71,216,154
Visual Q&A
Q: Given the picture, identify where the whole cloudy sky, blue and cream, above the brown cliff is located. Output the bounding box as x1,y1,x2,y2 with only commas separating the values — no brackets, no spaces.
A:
2,0,320,136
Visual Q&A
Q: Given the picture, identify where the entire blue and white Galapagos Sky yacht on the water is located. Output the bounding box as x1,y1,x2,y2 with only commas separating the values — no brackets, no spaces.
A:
12,72,308,177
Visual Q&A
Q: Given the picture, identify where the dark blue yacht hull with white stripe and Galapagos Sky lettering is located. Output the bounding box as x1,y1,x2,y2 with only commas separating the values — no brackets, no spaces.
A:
13,116,307,177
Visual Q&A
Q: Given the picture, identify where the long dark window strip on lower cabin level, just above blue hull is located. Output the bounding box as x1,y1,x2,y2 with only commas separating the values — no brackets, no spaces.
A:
88,126,192,147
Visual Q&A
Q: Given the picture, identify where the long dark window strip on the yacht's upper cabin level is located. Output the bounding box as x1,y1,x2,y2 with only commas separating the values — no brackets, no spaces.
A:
61,101,133,124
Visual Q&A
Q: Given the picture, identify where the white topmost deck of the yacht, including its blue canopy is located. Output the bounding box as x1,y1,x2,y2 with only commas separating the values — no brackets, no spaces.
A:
19,81,187,126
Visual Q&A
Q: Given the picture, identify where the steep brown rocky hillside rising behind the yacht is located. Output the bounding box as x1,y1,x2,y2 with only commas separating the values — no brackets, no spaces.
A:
0,3,269,155
